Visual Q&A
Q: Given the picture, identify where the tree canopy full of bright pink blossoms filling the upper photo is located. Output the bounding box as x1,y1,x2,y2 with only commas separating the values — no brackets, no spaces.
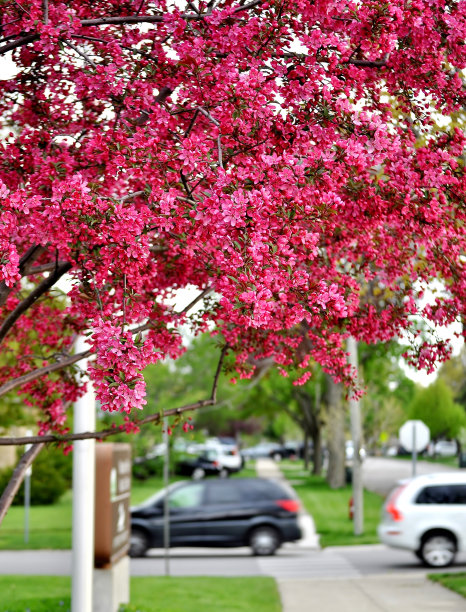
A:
0,0,466,454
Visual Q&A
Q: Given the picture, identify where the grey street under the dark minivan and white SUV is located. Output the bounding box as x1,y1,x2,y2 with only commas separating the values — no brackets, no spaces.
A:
0,544,466,579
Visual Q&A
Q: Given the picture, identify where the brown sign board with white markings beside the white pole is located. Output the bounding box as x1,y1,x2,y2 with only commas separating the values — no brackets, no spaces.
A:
94,443,131,567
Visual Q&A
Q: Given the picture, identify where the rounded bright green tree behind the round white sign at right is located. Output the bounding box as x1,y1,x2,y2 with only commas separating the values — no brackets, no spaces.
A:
408,379,466,440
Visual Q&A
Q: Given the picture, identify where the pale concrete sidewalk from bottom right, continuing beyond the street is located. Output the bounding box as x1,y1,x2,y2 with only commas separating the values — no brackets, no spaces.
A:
256,459,466,612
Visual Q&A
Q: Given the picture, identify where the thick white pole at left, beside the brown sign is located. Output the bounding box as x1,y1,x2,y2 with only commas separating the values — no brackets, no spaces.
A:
71,337,95,612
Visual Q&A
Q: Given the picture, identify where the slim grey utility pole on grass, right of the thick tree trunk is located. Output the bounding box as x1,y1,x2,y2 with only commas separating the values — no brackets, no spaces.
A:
346,336,364,535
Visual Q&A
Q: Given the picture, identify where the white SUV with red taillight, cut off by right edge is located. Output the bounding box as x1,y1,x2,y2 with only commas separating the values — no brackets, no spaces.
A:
378,472,466,567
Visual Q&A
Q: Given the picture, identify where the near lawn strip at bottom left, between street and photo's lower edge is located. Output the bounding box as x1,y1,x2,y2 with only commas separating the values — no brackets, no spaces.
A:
0,576,281,612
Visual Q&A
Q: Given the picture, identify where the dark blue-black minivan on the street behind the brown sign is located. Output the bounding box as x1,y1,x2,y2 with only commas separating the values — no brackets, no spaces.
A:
130,478,301,557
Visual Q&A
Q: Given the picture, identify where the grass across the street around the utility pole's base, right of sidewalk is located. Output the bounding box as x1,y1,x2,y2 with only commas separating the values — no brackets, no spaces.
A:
280,461,383,546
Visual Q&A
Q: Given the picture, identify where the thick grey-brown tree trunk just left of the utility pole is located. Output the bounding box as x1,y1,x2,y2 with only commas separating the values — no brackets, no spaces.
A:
325,374,346,489
